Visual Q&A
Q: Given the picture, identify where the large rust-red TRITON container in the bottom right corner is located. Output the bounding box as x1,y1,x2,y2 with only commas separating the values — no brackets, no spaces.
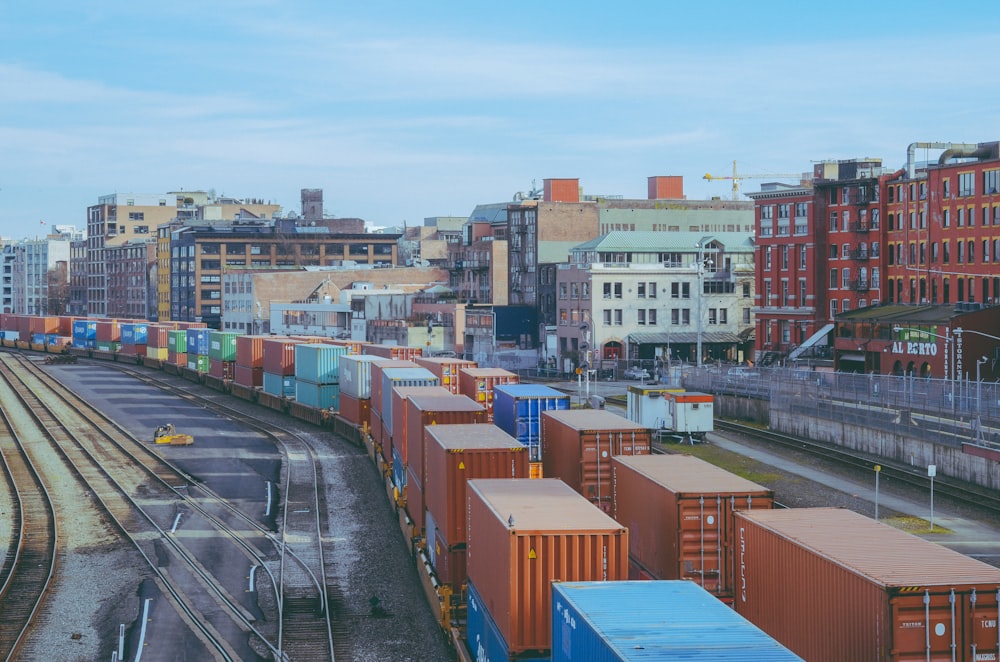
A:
734,508,1000,662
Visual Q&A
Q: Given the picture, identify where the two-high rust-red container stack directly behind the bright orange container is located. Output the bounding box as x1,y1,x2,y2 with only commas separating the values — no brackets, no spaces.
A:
424,424,528,595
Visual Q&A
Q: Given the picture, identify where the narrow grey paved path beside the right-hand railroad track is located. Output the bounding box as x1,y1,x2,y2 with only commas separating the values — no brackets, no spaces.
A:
708,433,1000,566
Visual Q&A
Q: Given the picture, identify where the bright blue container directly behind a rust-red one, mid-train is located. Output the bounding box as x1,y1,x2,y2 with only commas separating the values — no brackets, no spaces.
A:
493,384,570,462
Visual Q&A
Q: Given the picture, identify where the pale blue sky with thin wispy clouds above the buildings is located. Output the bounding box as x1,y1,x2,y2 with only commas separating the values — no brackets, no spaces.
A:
0,0,1000,237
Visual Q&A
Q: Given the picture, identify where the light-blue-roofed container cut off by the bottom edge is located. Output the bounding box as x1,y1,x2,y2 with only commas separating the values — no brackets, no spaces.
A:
552,581,802,662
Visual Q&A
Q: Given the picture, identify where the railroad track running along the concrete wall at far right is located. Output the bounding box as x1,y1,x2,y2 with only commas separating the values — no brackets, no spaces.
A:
715,419,1000,515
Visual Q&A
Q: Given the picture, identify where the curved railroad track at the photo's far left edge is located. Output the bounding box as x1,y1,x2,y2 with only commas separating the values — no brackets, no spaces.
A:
0,390,58,660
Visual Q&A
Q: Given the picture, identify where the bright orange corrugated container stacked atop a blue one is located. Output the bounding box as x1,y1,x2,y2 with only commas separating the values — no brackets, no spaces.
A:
466,478,628,653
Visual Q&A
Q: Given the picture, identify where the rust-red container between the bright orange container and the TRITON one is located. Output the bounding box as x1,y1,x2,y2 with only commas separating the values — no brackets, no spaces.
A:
611,455,774,602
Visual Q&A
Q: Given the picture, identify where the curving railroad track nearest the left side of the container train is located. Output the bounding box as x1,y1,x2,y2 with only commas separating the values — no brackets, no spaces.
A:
86,363,345,662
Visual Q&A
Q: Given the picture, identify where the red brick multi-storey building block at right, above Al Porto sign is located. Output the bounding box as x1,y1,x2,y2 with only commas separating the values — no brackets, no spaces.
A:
748,142,1000,376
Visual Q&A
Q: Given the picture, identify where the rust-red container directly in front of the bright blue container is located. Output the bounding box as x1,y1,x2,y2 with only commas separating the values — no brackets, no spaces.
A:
541,409,653,512
